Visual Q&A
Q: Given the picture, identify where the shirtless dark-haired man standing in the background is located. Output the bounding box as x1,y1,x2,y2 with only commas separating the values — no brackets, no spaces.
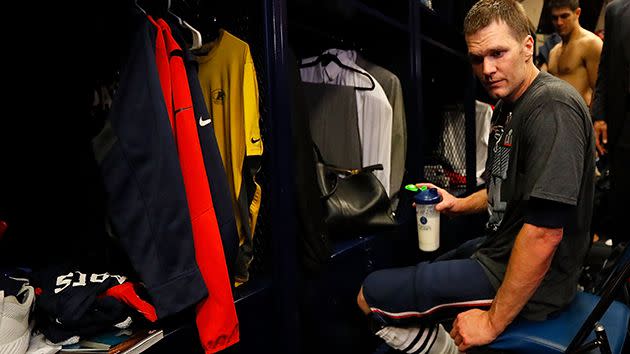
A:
541,0,603,107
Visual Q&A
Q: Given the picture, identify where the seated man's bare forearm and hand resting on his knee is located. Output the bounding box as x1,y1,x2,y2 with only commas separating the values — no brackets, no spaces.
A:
451,223,563,351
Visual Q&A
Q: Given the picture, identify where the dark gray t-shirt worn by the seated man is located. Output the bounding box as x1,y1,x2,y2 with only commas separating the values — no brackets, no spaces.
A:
473,72,595,320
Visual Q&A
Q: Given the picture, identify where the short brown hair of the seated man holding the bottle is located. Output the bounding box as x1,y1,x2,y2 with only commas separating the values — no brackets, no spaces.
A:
464,0,536,41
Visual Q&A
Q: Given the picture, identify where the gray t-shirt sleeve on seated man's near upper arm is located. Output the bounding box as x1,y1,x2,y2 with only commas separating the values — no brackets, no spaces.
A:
519,100,588,205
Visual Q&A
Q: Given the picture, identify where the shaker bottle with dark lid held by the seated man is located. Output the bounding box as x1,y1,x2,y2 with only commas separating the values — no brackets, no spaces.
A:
413,186,442,252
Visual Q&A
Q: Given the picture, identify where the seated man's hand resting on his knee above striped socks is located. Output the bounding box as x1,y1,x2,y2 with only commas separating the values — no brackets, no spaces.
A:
450,309,505,352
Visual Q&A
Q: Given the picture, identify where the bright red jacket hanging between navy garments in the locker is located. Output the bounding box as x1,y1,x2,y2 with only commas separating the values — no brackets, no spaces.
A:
149,19,239,353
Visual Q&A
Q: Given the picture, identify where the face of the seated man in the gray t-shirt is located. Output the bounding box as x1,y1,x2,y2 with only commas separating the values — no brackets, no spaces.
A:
466,21,533,102
